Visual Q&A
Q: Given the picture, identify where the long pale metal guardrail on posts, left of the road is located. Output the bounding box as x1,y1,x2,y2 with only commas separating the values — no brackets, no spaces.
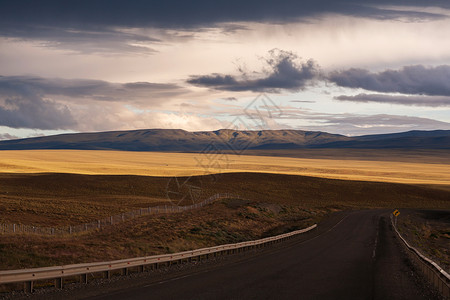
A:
0,224,317,292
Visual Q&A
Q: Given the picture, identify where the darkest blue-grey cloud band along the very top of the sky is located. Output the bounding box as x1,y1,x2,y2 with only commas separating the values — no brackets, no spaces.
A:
0,0,450,28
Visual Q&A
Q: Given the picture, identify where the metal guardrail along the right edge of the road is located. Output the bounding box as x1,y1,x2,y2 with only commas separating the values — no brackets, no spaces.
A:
391,215,450,299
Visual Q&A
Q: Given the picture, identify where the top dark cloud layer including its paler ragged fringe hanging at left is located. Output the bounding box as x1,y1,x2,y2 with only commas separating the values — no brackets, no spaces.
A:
0,0,450,53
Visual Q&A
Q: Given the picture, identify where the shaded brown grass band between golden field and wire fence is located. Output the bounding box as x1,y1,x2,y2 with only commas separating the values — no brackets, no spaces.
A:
0,173,450,226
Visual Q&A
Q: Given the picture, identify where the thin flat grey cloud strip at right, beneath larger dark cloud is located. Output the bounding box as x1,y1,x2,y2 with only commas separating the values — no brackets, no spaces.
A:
334,94,450,107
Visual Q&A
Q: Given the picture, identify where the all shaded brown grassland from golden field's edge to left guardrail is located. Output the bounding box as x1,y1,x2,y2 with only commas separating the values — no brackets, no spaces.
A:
0,173,450,269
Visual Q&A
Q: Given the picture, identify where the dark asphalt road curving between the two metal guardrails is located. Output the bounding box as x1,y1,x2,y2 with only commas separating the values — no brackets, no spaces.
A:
68,210,433,299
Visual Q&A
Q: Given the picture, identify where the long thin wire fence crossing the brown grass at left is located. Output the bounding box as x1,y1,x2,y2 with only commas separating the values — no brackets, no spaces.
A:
0,193,240,235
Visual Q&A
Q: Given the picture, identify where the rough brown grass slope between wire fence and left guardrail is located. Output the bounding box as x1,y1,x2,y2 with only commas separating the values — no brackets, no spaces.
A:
0,199,327,270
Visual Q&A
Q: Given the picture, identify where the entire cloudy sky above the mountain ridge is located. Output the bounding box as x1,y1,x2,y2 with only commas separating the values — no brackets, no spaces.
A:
0,0,450,140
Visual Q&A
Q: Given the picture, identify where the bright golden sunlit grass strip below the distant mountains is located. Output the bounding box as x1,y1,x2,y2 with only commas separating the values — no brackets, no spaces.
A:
0,150,450,187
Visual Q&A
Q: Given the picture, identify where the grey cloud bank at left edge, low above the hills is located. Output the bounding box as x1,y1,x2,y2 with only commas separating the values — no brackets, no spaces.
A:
0,76,185,129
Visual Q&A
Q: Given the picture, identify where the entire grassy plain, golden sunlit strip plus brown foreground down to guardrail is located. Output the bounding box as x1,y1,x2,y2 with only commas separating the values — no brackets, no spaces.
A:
0,150,450,276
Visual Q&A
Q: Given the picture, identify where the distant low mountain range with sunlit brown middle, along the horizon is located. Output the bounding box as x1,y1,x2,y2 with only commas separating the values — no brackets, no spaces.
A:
0,129,450,153
